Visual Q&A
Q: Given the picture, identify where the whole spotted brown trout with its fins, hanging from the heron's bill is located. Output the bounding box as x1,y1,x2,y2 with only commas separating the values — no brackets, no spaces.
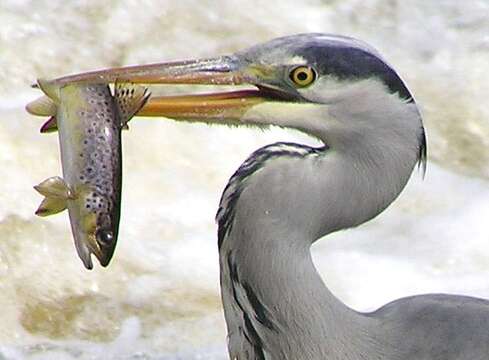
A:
26,80,150,269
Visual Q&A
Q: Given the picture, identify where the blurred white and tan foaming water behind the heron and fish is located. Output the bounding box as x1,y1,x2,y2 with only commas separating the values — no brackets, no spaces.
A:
0,0,489,360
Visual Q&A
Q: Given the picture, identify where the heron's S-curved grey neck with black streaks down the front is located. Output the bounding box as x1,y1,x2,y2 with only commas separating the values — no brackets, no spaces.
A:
218,95,420,360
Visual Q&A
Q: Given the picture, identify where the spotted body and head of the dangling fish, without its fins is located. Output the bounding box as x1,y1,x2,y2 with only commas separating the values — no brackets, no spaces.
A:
61,85,122,268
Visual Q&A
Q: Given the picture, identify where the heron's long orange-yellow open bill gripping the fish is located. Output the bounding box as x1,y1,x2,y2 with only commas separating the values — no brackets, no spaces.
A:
42,55,297,124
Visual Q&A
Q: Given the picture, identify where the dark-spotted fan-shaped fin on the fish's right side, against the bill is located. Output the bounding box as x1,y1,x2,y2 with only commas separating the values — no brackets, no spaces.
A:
114,81,151,128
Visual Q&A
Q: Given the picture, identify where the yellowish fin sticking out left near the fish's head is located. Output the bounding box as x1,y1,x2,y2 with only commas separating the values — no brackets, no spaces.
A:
34,176,73,216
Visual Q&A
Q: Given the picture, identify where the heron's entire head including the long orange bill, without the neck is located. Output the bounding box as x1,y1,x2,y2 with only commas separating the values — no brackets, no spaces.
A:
47,34,426,166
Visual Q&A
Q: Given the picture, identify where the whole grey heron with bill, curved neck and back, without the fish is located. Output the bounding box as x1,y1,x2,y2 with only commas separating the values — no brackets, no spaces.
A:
46,34,489,360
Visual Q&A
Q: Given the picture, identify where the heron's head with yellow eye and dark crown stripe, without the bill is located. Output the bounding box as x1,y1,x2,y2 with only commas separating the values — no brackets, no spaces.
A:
233,34,426,167
